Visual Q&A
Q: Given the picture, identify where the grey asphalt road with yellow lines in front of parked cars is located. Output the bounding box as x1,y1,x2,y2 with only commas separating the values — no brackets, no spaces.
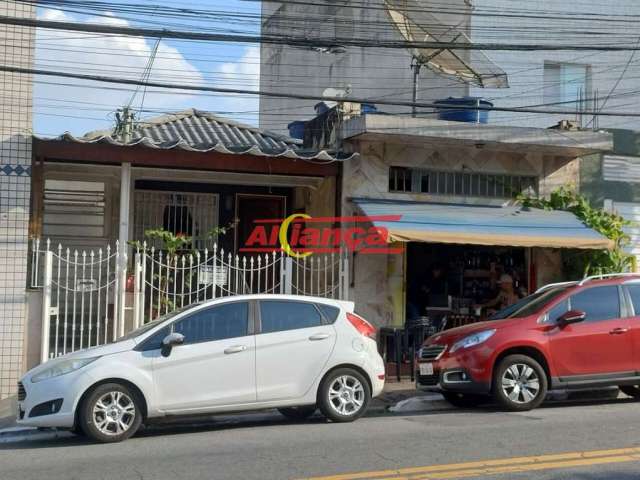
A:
0,399,640,480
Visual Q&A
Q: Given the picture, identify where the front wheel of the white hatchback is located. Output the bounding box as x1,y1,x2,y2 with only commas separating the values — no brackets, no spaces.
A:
79,383,142,443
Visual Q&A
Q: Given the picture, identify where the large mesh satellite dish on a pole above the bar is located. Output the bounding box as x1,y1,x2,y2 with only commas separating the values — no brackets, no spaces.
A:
384,0,509,88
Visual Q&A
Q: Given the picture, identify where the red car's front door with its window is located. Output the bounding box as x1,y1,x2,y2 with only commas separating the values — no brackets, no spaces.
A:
550,285,635,382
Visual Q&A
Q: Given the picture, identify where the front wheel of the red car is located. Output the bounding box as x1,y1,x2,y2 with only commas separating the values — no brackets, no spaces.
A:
493,355,547,412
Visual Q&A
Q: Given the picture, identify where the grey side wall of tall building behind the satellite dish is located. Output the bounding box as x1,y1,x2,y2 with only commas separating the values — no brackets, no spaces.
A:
260,0,466,133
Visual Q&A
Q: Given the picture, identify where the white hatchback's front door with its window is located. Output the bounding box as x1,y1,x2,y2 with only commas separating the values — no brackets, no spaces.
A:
153,302,256,412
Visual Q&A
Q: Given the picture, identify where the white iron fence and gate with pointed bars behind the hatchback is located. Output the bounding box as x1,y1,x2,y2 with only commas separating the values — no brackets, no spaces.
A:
31,240,349,361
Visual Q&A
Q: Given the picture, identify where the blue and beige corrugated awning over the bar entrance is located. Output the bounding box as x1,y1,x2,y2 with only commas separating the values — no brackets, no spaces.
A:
353,199,612,249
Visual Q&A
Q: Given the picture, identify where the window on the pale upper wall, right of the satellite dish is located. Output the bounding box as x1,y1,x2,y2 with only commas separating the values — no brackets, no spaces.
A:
544,62,591,109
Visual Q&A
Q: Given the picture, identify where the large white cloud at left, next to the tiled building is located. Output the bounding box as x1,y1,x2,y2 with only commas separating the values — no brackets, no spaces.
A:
34,10,204,133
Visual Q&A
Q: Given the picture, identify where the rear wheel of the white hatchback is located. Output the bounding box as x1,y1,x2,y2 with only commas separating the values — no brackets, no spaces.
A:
318,368,371,422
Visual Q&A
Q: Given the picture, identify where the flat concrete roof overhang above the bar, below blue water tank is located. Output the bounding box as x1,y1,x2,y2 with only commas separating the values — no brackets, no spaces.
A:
341,114,613,158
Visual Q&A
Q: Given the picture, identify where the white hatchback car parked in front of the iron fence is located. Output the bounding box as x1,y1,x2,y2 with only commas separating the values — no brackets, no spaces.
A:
18,295,385,442
